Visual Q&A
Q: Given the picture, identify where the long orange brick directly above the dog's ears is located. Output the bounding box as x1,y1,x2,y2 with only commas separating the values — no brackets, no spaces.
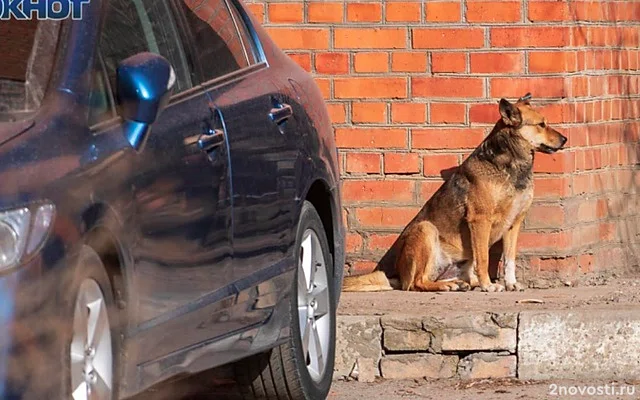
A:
491,78,565,98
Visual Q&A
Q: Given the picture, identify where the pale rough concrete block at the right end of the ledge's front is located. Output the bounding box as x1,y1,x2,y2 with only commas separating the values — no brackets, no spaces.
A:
518,307,640,379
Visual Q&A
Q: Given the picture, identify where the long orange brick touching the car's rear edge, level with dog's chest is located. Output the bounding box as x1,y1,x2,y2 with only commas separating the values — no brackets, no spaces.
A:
342,180,415,203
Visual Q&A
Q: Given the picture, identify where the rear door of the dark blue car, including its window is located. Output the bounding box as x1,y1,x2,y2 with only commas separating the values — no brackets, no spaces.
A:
176,0,297,329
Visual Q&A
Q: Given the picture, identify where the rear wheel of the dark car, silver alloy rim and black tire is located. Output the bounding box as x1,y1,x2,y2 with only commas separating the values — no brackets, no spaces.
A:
235,201,336,400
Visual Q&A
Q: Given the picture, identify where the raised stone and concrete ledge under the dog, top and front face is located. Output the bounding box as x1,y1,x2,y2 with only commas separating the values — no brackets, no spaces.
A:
335,278,640,382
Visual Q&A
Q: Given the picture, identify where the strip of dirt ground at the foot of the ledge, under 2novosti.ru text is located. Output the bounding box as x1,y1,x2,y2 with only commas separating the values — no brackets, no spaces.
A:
328,379,640,400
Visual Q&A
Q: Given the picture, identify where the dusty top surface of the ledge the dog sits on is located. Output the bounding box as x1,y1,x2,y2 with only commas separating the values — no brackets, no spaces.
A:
338,276,640,316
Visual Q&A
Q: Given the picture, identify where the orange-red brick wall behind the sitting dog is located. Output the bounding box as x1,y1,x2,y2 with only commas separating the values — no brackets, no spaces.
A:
244,0,640,282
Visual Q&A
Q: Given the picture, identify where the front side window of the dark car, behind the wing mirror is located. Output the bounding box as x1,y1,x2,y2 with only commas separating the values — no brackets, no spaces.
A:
89,0,193,125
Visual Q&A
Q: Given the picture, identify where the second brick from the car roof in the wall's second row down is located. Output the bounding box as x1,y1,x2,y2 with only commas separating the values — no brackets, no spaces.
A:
334,28,407,49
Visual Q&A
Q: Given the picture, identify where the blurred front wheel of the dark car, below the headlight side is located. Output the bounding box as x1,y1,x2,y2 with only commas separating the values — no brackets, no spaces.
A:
57,246,121,400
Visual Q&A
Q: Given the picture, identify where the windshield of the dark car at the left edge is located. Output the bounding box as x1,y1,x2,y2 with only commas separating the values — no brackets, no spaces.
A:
0,19,60,122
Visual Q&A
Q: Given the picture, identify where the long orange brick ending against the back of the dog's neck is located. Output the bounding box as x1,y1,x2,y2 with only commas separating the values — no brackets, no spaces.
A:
411,128,484,150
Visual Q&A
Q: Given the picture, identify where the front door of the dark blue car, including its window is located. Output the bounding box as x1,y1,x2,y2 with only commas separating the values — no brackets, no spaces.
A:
86,0,235,363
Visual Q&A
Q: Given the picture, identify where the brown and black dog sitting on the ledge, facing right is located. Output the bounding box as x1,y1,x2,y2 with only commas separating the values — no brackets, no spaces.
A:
343,93,567,292
